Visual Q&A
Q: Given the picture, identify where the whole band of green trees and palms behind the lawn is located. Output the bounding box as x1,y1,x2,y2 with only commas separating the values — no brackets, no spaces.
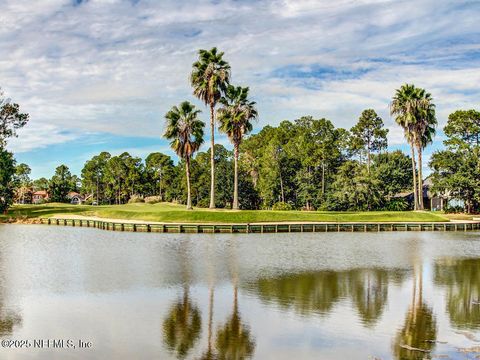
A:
0,48,480,212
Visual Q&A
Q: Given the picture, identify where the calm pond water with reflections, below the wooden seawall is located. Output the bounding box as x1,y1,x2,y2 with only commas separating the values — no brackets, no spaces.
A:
0,225,480,359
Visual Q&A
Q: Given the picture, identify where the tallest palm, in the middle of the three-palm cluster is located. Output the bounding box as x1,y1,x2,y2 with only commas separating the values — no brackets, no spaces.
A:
190,47,230,209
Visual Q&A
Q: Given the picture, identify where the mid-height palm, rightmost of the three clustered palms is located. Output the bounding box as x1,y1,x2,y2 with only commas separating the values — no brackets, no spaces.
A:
217,85,258,210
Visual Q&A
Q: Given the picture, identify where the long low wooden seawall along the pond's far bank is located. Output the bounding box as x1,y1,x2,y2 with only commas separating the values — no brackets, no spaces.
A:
38,218,480,234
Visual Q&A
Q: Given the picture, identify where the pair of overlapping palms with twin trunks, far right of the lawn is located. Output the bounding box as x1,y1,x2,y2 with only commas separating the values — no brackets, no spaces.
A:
390,84,437,210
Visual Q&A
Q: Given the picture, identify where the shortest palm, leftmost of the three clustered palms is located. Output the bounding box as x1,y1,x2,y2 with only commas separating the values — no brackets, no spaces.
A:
163,101,205,210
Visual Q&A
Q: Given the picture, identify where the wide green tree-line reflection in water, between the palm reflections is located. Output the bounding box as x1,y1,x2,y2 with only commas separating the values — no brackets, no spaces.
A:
251,268,407,327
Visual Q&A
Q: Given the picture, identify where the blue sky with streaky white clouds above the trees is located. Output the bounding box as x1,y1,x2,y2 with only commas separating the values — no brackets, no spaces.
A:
0,0,480,177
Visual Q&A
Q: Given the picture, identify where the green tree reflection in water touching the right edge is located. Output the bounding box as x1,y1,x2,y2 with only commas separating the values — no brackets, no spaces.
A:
434,258,480,330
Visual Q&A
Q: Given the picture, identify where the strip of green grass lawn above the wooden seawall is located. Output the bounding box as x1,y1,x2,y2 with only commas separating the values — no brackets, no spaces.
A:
0,203,448,223
